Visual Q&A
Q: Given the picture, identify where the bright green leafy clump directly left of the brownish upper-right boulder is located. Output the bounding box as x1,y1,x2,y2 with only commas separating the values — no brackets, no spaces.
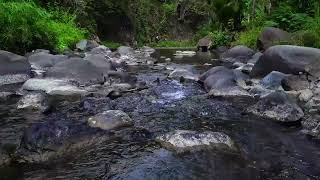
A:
232,27,262,49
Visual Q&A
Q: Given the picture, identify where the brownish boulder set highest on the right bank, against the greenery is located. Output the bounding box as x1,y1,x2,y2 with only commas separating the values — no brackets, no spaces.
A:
257,27,290,51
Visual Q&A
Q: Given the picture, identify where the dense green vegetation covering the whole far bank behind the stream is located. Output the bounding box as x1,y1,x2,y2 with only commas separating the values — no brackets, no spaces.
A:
0,0,320,53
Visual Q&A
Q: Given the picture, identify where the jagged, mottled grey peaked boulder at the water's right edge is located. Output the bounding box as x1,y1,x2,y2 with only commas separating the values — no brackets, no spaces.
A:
248,91,304,122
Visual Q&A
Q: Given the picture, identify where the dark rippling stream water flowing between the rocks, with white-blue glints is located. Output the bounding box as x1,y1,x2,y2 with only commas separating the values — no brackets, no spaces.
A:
0,49,320,180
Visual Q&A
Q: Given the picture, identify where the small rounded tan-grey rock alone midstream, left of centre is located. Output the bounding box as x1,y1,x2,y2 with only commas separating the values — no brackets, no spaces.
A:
88,110,133,130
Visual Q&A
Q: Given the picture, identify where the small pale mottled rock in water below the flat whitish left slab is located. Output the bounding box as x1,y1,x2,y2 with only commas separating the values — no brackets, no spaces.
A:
17,92,49,112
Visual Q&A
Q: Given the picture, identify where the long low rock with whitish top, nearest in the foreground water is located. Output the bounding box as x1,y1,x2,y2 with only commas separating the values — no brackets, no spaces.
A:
156,130,236,152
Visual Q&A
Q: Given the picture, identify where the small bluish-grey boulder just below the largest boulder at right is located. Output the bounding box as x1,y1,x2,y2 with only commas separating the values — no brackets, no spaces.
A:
260,71,286,90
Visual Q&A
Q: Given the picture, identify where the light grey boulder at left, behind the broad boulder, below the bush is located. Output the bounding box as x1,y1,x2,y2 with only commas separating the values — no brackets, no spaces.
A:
28,52,68,70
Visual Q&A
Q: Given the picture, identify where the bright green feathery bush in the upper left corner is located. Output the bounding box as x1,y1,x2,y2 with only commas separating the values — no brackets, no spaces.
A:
0,1,85,53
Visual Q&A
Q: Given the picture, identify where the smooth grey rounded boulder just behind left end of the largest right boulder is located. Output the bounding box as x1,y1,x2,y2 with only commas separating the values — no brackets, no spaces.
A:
221,46,255,63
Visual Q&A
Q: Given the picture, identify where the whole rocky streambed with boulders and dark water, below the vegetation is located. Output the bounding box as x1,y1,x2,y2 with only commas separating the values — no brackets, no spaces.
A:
0,42,320,180
